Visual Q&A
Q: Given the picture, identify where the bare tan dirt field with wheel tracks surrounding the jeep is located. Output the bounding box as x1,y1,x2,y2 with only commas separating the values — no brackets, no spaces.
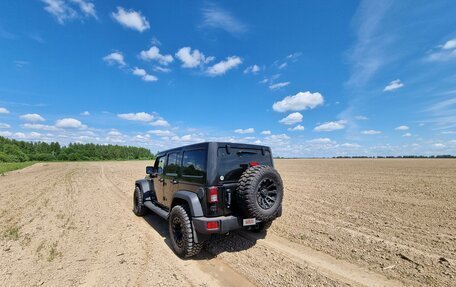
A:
0,160,456,286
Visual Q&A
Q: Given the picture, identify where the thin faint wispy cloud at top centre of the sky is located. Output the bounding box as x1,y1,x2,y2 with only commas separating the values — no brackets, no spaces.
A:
201,5,247,36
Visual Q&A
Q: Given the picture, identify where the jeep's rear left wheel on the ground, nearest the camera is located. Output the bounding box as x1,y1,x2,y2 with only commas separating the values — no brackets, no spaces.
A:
169,205,203,257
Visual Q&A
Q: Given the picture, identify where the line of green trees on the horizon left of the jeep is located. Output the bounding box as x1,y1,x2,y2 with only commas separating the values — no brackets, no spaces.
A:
0,137,154,162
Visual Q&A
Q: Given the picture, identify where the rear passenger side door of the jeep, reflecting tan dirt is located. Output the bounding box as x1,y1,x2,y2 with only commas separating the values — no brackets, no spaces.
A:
163,151,181,207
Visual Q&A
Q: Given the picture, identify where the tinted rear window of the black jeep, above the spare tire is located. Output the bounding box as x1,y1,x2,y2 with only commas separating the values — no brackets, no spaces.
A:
217,147,272,181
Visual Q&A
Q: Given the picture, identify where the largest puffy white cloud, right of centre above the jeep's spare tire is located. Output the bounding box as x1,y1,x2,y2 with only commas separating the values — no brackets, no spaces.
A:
272,92,324,112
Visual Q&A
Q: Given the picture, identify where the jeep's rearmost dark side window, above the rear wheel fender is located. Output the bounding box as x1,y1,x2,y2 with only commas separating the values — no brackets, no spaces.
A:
182,150,206,183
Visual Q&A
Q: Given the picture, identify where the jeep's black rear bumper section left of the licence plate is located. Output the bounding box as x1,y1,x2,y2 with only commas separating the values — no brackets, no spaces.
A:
192,215,242,234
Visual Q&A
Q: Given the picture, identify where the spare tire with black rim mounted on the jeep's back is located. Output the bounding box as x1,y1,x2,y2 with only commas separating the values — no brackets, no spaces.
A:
236,165,283,221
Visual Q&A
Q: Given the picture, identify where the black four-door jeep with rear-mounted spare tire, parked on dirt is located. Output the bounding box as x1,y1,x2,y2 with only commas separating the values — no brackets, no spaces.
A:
133,142,283,257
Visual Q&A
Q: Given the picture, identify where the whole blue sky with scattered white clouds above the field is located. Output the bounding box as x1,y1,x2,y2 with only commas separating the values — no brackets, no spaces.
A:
0,0,456,157
